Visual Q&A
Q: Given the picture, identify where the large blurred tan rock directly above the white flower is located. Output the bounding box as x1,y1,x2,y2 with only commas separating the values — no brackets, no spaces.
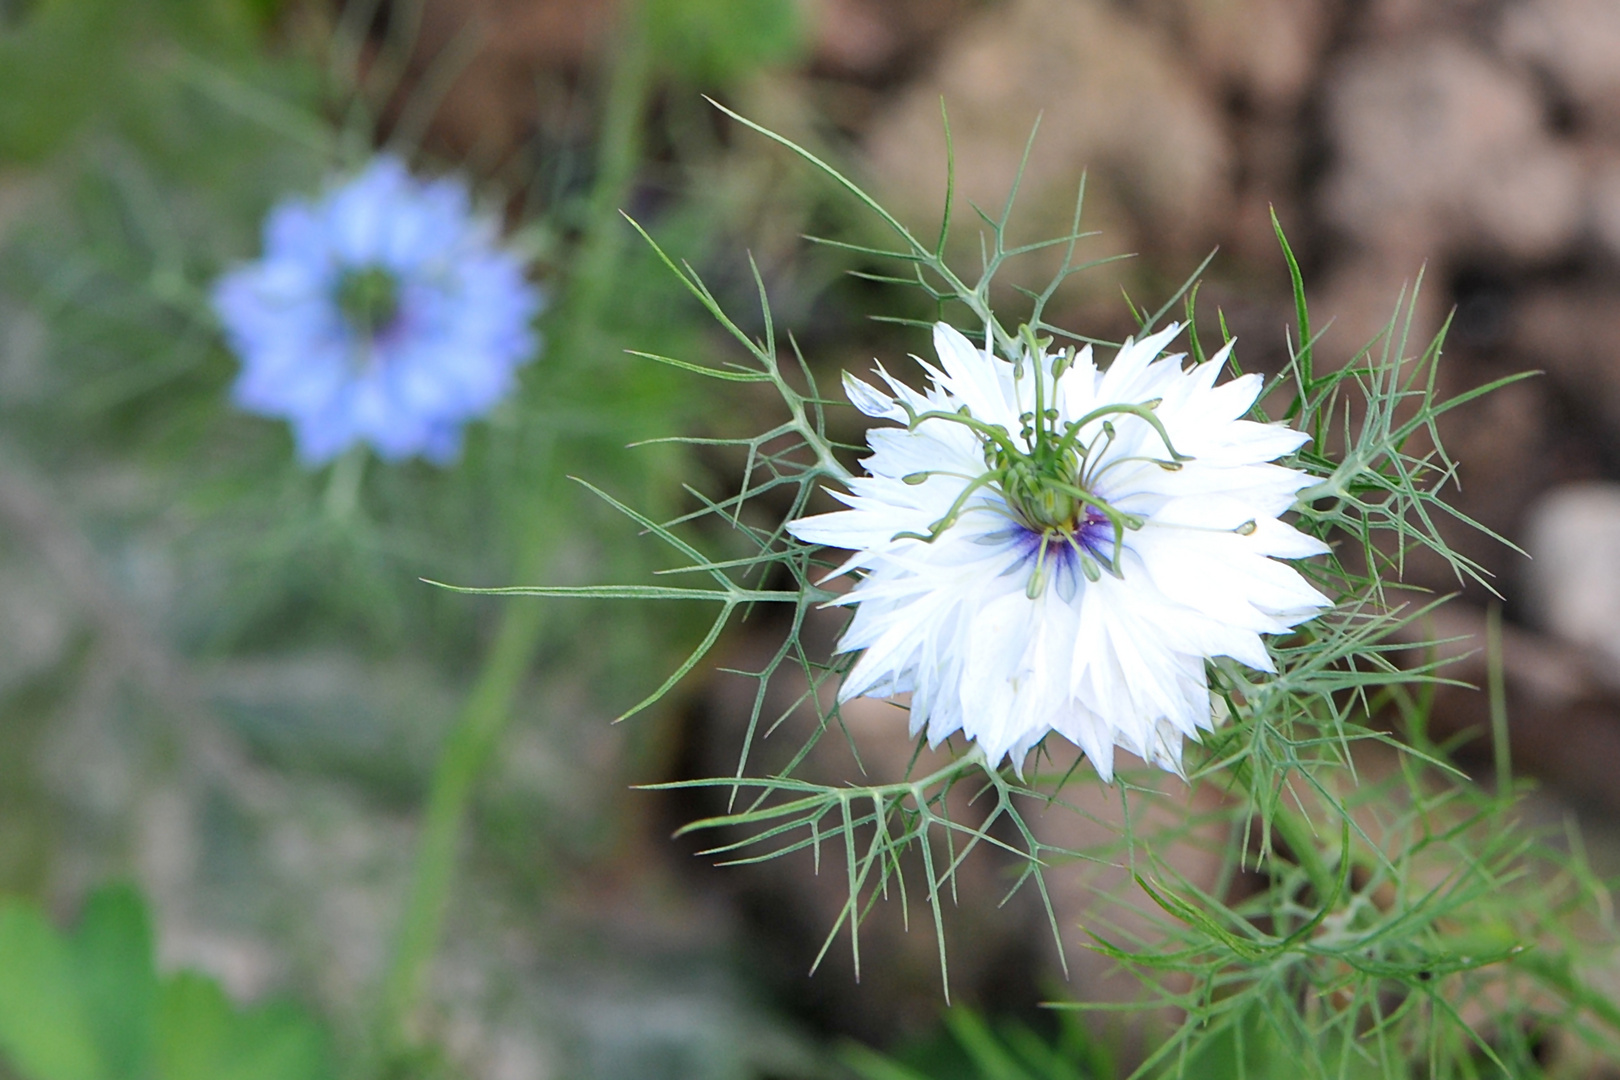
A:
865,0,1231,285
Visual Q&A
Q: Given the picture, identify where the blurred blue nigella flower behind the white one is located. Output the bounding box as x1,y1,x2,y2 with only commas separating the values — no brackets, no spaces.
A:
214,155,541,465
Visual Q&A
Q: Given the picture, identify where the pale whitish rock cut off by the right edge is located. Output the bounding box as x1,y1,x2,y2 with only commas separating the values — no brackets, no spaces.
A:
1524,481,1620,669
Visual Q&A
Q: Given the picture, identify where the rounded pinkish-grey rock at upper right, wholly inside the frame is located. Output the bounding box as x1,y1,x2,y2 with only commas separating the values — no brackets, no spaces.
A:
1322,39,1583,264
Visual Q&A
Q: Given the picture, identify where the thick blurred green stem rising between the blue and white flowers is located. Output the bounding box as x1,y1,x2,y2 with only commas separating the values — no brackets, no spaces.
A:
376,11,650,1065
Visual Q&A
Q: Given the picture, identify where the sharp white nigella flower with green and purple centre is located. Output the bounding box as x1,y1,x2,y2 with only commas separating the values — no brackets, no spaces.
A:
789,324,1328,779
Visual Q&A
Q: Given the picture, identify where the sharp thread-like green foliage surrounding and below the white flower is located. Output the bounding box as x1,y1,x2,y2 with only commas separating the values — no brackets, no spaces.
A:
473,108,1620,1080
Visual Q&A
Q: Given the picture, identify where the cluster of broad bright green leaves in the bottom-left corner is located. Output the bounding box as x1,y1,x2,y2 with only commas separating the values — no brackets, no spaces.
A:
0,886,332,1080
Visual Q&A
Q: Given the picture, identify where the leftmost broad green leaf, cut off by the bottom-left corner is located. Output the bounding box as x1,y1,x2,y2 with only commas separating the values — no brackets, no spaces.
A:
0,900,109,1080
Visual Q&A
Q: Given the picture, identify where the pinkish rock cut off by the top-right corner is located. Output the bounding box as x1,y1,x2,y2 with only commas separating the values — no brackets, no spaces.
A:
1500,0,1620,134
